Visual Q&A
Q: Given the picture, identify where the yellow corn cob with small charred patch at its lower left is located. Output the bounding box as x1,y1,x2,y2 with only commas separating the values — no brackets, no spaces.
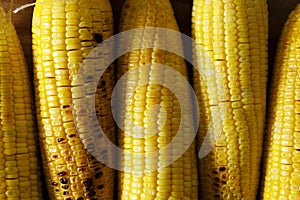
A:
192,0,268,199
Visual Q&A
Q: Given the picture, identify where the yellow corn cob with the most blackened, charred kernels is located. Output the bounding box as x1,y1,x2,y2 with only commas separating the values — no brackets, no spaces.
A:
32,0,115,200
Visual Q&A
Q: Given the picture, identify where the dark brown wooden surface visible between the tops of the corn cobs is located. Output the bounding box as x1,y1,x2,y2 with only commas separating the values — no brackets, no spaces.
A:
3,0,300,69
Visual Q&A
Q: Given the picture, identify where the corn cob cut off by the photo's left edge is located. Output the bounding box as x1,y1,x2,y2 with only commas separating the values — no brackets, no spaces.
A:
0,5,42,200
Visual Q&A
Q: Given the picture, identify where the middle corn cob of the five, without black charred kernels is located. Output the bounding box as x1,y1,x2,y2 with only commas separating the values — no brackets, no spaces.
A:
117,0,198,200
